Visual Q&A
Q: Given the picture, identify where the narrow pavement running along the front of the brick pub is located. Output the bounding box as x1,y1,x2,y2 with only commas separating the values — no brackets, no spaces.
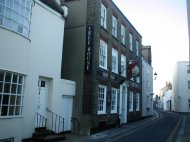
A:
62,112,159,142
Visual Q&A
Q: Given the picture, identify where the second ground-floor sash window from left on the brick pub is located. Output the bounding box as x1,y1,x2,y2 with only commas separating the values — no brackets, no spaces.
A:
111,88,118,113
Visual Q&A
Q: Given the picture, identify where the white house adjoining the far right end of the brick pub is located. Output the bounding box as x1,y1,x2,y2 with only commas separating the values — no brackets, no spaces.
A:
142,58,153,117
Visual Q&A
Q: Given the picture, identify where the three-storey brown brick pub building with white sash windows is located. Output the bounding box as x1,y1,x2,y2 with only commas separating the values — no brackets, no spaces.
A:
62,0,142,135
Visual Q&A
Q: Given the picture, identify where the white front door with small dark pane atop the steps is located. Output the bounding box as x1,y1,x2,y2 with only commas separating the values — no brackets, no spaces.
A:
37,79,48,118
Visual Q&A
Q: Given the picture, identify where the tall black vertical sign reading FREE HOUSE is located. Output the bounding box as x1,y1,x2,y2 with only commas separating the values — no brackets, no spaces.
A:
85,25,93,73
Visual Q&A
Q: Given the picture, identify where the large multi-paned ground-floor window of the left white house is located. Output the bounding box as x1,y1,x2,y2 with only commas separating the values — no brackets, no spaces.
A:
0,70,25,117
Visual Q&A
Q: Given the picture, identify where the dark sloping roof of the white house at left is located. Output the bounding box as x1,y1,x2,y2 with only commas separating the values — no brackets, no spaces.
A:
40,0,64,15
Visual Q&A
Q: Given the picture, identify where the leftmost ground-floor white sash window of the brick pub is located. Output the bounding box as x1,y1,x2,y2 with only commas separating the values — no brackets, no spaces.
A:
97,84,107,114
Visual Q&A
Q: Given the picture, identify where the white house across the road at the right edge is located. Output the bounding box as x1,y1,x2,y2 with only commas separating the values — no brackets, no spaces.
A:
172,61,190,112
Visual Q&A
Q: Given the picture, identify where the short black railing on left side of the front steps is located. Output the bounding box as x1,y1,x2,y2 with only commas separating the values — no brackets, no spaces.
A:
36,112,47,128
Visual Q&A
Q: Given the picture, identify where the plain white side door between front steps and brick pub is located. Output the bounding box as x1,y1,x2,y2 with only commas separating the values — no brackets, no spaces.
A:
62,96,73,131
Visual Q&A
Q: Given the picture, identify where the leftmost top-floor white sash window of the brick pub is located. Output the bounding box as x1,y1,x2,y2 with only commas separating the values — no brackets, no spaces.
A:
100,3,107,29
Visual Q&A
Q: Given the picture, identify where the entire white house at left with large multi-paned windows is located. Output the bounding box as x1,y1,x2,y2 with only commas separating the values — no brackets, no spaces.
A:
0,0,76,142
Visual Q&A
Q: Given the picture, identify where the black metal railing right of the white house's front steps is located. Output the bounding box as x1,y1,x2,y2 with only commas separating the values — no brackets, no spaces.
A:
47,109,64,133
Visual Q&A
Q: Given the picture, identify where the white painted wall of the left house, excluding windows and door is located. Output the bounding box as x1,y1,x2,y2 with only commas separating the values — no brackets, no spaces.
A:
0,0,76,142
